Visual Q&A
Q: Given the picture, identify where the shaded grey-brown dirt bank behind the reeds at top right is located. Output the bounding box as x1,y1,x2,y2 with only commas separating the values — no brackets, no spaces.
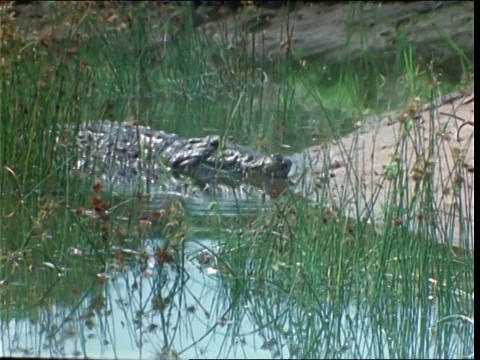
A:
200,1,474,63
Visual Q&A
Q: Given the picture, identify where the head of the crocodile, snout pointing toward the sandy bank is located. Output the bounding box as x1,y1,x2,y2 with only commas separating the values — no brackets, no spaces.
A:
168,136,292,197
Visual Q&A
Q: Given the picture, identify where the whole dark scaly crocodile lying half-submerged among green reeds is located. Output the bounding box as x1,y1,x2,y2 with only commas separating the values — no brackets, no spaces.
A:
60,120,292,197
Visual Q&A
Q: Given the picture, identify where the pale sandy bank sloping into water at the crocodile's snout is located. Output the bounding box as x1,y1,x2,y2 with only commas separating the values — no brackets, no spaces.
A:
288,90,475,250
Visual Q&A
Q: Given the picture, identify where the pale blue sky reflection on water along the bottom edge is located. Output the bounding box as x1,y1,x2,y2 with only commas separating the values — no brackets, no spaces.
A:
0,235,473,359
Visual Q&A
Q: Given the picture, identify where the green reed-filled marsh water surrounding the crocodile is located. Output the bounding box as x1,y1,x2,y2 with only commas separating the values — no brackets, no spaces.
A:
0,2,474,358
